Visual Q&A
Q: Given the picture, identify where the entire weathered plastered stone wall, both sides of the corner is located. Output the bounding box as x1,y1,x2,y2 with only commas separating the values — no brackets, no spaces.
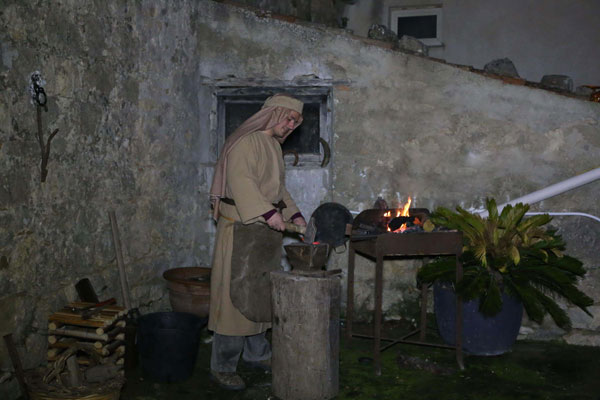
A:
0,0,600,398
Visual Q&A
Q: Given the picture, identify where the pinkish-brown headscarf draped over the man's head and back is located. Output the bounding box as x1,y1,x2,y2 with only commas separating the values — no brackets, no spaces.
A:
210,93,304,220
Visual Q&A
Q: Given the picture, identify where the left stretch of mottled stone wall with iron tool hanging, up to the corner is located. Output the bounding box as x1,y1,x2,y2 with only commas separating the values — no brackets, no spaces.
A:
0,1,212,398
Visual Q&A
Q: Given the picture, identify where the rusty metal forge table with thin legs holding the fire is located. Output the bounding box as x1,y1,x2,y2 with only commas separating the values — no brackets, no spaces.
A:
346,231,464,375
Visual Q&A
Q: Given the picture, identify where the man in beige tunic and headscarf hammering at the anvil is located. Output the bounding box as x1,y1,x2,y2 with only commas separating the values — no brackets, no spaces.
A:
208,94,306,390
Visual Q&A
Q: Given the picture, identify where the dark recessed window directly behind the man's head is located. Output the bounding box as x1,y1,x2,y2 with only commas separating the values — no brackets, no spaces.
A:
217,87,331,166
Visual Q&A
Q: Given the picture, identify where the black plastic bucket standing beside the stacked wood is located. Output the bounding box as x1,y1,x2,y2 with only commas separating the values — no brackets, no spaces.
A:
137,312,207,382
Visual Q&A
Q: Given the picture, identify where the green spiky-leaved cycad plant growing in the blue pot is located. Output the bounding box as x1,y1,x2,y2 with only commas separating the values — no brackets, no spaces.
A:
418,199,593,329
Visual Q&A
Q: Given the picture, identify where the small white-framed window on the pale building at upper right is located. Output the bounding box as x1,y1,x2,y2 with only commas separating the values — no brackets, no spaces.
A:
390,6,442,46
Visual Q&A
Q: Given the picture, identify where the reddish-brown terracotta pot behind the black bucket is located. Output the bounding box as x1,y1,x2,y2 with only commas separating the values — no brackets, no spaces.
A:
163,267,210,317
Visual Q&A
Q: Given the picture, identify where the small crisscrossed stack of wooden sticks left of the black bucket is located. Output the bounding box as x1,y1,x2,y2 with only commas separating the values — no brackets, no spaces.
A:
44,302,127,387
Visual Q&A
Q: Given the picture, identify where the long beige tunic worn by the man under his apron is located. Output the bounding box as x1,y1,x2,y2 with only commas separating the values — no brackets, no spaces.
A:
208,132,299,336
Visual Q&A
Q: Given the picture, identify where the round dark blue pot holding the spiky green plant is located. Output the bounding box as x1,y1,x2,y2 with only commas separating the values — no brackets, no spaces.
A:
433,283,523,356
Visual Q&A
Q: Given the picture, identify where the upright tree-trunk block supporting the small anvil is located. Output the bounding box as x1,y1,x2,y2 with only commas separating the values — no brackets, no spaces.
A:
271,271,341,400
